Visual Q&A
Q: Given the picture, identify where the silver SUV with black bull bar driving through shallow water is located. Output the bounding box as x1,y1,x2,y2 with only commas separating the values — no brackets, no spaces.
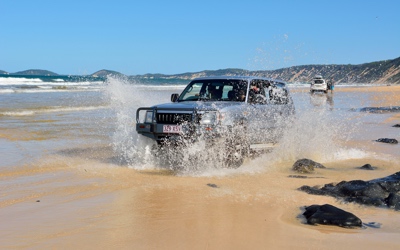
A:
136,76,295,167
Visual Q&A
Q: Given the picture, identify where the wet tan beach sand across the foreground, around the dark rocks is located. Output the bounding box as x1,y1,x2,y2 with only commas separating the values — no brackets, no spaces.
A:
0,86,400,249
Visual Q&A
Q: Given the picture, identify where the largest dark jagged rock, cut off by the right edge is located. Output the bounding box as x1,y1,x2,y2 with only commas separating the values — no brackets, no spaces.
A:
299,172,400,210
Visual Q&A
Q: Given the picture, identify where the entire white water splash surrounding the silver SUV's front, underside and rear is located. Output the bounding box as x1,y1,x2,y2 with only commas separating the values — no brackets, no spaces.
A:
105,77,365,176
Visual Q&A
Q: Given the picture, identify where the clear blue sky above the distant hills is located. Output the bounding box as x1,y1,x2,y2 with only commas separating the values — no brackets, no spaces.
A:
0,0,400,75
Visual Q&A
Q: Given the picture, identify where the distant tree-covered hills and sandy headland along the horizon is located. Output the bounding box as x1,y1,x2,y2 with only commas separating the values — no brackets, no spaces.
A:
0,57,400,84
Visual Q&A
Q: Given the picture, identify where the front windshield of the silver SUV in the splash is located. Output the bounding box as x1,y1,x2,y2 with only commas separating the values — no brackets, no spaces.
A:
178,79,247,102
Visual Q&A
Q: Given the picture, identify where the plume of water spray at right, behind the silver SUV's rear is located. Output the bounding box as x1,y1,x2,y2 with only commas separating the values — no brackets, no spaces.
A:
264,96,367,167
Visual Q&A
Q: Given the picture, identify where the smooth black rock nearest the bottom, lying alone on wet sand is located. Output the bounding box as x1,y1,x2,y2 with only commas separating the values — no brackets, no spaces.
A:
303,204,362,227
